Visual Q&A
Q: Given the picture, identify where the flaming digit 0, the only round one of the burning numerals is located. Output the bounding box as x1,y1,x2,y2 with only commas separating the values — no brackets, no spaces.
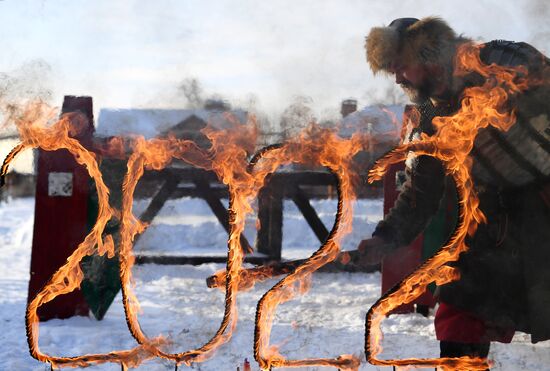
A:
120,116,270,365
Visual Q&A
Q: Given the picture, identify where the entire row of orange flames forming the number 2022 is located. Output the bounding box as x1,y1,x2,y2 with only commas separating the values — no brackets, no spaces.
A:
0,40,531,370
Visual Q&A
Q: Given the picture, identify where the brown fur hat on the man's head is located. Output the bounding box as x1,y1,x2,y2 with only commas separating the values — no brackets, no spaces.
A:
365,17,461,73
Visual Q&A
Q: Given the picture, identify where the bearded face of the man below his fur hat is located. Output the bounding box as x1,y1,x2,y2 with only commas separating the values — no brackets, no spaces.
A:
389,63,435,104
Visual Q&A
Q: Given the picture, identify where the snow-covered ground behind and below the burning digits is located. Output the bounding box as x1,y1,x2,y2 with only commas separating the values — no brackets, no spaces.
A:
0,199,550,371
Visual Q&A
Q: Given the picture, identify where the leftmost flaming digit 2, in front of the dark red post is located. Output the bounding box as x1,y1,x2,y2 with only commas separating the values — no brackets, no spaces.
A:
1,102,168,367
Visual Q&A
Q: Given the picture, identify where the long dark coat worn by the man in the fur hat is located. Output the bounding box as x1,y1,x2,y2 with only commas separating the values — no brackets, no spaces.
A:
373,41,550,342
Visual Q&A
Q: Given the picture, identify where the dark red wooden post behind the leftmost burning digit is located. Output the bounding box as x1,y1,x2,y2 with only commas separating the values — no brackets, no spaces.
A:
28,96,94,320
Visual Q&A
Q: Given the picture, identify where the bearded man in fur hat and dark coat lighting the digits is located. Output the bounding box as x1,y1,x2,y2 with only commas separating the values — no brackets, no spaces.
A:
358,18,550,357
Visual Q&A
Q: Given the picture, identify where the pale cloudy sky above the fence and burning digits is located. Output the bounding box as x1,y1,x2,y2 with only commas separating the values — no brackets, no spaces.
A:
0,0,550,120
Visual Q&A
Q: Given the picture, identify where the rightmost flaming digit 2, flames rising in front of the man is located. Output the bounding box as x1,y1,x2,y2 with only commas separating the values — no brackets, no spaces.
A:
365,45,532,370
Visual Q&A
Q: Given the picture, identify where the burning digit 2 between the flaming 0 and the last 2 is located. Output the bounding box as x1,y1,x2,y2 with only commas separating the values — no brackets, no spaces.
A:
251,127,368,370
